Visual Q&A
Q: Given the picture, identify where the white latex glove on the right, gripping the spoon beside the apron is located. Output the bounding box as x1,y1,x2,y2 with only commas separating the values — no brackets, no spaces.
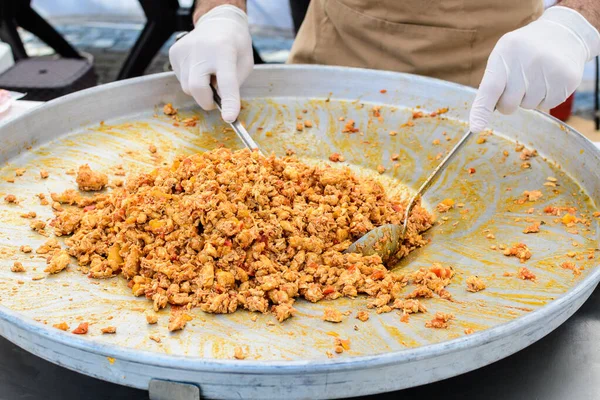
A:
470,6,600,132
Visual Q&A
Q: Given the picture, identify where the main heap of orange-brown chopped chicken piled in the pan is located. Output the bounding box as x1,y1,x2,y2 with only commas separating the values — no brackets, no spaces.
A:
49,148,432,331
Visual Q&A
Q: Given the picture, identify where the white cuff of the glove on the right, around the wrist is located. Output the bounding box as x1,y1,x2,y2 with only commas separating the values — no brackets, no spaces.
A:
540,6,600,61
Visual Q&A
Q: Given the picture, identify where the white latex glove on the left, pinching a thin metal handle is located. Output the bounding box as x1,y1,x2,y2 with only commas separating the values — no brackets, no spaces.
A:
169,5,254,122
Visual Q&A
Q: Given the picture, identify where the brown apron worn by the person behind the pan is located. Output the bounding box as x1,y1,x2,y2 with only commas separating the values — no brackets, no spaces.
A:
290,0,544,86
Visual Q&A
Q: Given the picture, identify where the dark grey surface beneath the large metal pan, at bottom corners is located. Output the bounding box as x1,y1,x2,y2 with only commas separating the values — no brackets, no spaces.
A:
0,288,600,400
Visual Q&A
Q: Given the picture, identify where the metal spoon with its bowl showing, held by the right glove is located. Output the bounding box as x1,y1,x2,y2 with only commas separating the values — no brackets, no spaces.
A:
344,131,472,262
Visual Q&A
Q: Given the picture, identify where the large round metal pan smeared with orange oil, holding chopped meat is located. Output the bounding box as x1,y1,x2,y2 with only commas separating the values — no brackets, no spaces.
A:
0,66,600,399
